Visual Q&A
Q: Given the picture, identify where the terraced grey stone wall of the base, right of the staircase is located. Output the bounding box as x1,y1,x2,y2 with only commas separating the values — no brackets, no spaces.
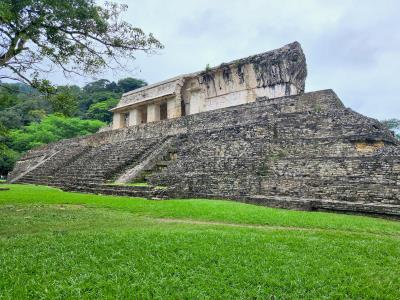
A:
145,92,400,213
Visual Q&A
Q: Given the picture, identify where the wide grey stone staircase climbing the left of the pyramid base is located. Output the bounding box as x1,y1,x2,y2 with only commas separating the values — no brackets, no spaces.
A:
17,138,176,199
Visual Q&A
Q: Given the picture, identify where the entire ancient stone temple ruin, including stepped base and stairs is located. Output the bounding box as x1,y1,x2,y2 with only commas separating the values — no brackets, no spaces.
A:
8,43,400,217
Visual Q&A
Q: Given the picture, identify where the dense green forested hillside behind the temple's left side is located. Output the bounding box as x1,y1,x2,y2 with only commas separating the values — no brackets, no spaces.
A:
0,77,147,176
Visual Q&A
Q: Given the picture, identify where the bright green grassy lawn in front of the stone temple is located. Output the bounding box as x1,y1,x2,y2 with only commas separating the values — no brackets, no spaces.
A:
0,184,400,299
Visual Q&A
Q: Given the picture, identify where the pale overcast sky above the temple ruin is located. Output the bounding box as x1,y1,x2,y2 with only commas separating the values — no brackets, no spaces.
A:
61,0,400,119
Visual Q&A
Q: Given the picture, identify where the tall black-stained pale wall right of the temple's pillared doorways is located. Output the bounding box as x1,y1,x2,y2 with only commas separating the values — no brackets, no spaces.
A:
182,42,307,114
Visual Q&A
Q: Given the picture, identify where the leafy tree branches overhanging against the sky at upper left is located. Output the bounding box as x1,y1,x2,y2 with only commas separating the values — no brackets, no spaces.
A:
0,0,163,91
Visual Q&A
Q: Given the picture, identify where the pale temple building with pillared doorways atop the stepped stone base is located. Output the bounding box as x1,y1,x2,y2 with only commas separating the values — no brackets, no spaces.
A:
111,42,307,129
